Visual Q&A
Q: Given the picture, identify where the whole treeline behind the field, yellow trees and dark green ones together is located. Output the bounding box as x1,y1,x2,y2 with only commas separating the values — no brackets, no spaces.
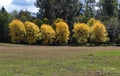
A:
0,0,120,45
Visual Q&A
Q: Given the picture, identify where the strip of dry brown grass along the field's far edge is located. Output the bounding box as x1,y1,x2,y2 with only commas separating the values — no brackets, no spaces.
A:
0,44,120,58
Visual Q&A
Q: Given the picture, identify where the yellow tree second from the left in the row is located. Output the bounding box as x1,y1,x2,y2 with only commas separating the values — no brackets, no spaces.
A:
25,21,40,44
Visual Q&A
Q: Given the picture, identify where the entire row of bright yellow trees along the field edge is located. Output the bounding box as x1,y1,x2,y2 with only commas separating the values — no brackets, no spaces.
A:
9,18,109,45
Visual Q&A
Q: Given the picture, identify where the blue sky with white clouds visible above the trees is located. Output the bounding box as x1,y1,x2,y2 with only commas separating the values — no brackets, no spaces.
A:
0,0,118,13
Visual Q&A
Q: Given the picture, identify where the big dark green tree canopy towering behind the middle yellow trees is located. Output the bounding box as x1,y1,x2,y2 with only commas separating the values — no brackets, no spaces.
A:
35,0,82,27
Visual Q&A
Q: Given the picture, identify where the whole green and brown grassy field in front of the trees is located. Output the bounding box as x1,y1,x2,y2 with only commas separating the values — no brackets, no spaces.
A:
0,43,120,76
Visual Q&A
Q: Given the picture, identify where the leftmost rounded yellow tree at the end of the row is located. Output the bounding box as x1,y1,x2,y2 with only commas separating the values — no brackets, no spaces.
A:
9,19,26,43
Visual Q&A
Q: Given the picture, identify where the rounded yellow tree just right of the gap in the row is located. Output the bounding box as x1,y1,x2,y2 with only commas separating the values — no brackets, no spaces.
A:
72,23,90,44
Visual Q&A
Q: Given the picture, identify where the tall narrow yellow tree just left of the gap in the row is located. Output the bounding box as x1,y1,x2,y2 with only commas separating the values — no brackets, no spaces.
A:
55,22,70,45
